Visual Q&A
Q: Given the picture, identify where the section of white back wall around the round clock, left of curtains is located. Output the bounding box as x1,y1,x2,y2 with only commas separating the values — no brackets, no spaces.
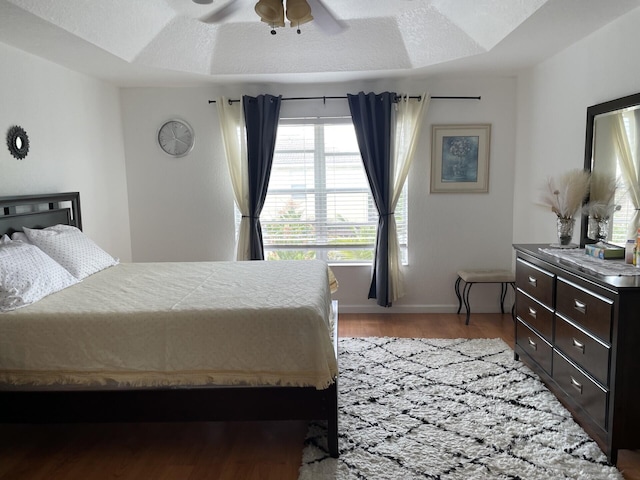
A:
121,88,234,262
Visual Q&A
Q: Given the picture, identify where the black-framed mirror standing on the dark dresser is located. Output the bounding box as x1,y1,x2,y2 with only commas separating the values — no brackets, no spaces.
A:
580,93,640,247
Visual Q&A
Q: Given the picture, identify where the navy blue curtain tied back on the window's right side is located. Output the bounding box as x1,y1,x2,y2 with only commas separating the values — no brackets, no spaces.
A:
347,92,397,307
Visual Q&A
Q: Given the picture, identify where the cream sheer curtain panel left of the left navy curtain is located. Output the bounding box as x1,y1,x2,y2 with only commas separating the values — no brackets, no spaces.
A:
216,97,250,260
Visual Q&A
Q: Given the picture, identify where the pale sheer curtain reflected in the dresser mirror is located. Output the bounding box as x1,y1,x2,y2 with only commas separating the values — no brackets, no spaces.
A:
613,114,640,238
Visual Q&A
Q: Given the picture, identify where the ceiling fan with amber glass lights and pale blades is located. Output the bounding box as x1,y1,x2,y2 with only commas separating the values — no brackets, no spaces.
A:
193,0,347,35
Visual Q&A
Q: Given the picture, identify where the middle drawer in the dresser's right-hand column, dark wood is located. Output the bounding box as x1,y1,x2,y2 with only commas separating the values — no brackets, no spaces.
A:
555,315,611,385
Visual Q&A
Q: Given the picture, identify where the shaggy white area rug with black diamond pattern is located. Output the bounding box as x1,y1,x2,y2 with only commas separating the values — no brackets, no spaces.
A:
299,338,623,480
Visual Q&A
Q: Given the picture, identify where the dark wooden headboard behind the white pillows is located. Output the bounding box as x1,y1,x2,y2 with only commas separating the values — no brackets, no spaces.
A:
0,192,82,236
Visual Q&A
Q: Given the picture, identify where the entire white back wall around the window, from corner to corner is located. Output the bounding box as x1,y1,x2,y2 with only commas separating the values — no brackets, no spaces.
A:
121,78,516,312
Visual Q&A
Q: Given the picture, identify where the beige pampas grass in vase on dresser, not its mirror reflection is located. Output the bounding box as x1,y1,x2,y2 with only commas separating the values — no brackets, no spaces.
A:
542,168,591,219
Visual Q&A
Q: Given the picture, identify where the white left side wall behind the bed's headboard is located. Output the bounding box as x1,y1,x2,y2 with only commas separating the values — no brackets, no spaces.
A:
0,43,131,261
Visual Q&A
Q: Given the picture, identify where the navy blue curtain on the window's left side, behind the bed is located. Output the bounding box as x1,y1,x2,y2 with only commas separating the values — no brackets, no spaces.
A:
242,95,282,260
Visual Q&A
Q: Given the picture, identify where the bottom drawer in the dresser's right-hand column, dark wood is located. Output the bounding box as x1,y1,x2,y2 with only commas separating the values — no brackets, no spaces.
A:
553,350,608,430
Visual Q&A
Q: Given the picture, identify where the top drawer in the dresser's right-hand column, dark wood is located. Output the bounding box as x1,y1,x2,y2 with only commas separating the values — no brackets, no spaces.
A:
556,277,613,344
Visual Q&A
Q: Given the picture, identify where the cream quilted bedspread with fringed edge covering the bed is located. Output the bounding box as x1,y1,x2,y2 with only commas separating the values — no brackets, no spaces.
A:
0,261,337,389
